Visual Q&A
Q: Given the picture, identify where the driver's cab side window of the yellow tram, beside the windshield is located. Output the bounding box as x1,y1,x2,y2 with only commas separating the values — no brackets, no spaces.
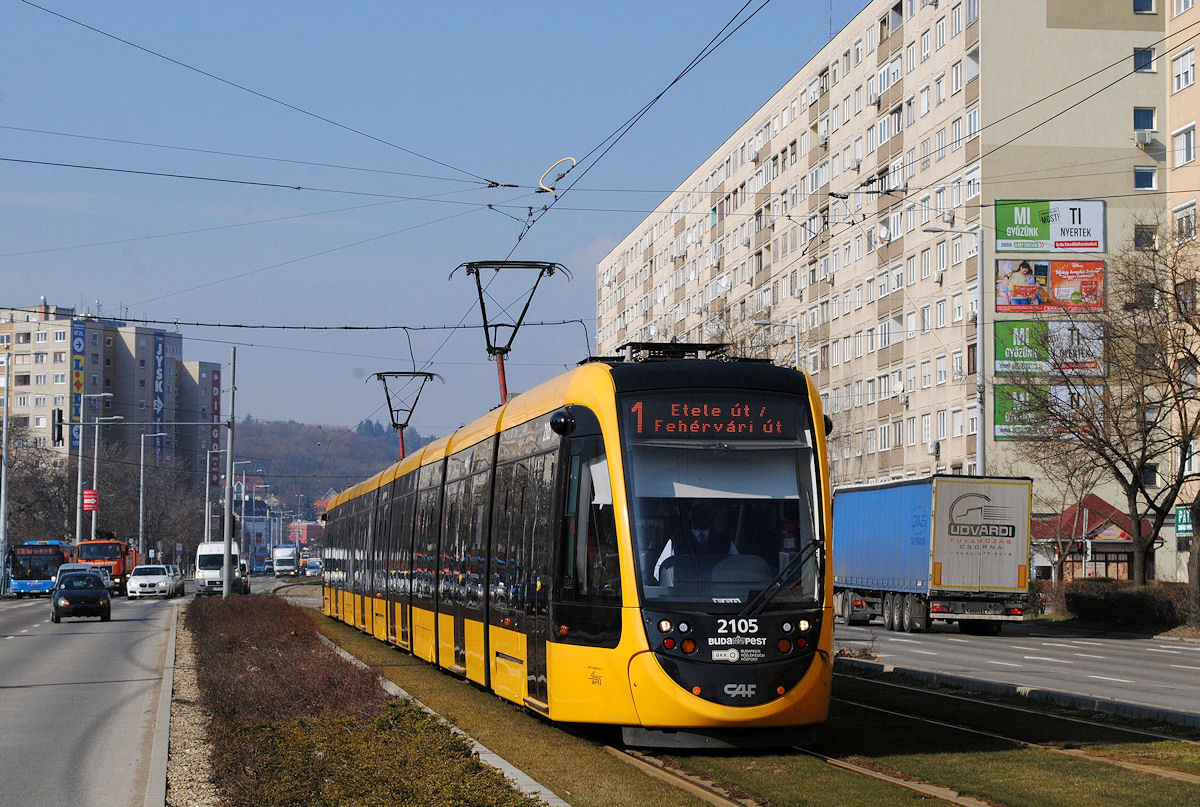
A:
558,437,620,604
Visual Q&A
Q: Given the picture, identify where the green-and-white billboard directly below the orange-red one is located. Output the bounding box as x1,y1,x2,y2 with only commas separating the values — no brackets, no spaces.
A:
992,319,1108,376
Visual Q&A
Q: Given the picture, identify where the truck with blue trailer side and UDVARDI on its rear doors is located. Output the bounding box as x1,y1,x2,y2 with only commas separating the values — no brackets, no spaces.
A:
833,474,1032,635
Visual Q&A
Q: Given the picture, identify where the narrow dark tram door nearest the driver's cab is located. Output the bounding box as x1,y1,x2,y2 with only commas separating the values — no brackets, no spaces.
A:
526,453,557,704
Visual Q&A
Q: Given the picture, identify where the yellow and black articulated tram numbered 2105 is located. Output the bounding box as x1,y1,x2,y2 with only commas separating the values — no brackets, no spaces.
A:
323,346,833,747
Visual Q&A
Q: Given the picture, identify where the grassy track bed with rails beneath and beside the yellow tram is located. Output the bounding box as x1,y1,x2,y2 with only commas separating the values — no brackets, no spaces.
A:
318,618,1200,807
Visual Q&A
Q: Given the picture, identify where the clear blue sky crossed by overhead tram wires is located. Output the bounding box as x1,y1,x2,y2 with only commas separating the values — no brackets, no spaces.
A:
0,0,862,434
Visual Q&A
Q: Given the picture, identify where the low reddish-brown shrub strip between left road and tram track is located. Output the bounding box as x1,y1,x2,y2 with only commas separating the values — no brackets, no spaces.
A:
185,596,538,807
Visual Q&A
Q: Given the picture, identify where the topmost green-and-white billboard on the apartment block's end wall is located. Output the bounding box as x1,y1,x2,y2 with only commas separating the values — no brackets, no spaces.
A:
995,199,1106,252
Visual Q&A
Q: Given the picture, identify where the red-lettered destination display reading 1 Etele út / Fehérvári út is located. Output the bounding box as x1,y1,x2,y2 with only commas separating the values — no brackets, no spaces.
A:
623,391,800,440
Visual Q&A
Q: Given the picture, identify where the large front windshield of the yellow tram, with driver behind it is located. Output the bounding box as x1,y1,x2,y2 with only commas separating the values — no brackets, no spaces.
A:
626,393,821,612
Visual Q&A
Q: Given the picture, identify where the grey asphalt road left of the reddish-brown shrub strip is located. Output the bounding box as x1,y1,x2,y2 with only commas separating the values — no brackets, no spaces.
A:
0,586,184,807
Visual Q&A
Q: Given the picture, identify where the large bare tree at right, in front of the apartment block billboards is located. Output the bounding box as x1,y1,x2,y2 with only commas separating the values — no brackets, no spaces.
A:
996,220,1200,584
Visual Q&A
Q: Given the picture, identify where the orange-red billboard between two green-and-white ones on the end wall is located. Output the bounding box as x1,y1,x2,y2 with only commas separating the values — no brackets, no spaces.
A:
996,258,1104,313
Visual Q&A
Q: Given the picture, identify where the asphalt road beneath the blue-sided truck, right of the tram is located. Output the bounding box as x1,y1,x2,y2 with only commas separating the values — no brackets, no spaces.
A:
834,622,1200,713
